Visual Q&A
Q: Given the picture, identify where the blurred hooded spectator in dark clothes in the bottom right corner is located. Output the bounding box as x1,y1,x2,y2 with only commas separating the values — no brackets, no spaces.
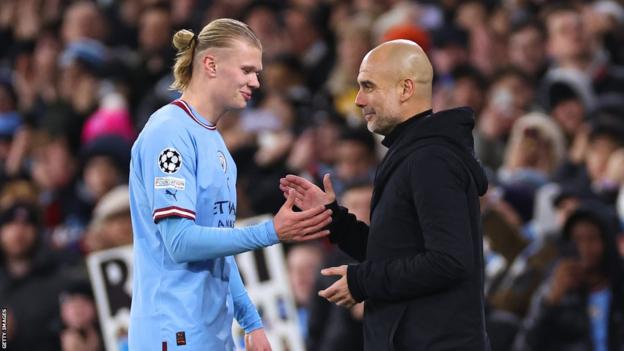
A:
515,207,624,351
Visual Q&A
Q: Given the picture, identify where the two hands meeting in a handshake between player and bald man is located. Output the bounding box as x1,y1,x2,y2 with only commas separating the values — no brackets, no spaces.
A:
273,174,336,242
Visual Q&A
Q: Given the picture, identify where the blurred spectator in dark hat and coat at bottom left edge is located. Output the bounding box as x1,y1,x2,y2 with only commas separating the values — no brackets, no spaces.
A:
0,203,63,351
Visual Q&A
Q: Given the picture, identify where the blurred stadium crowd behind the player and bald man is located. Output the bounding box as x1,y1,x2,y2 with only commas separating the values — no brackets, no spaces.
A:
0,0,624,351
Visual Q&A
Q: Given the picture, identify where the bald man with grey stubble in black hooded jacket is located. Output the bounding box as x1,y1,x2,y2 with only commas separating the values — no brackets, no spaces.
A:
280,40,490,351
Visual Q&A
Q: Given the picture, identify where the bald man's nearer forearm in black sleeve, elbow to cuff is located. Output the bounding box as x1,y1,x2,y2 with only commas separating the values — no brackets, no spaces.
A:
347,251,472,301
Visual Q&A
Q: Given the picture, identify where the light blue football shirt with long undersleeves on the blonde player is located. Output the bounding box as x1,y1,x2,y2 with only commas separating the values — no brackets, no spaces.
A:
129,100,278,351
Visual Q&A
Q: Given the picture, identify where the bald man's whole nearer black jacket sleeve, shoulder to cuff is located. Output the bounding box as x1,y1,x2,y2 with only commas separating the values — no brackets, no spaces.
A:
347,149,478,301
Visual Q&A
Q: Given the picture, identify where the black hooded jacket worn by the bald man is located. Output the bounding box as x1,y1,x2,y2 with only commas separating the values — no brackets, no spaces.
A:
329,108,489,351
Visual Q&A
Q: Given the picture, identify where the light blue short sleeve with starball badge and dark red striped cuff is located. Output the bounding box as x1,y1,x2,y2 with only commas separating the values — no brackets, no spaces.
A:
141,126,197,222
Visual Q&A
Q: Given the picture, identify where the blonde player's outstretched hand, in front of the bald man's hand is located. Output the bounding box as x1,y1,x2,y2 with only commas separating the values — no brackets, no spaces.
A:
273,190,332,242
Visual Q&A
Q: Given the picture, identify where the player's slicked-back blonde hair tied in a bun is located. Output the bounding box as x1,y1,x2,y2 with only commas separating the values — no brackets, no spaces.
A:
171,18,262,92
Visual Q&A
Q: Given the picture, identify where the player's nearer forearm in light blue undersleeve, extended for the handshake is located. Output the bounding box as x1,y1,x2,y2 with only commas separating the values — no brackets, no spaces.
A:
158,217,279,263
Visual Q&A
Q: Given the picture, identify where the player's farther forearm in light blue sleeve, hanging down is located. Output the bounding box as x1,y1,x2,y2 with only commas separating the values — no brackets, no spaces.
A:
227,256,262,334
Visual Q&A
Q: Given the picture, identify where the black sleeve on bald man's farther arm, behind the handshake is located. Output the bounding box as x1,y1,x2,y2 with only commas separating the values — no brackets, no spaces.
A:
326,201,368,262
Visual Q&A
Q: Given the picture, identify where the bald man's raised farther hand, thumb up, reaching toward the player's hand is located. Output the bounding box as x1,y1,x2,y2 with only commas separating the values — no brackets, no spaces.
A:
280,173,336,210
